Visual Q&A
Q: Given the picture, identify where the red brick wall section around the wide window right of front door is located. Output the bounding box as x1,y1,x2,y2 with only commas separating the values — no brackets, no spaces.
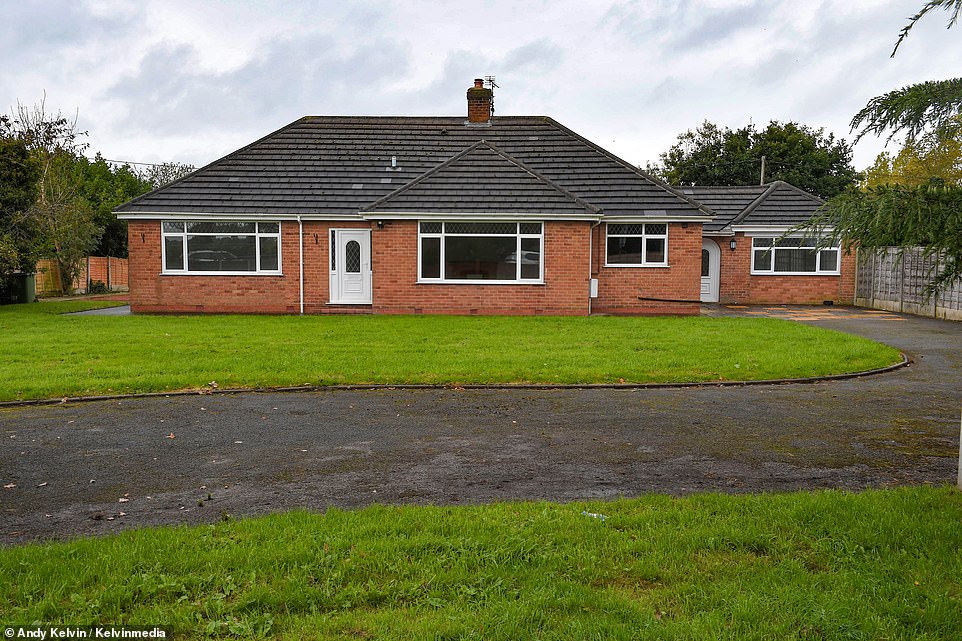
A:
371,220,589,315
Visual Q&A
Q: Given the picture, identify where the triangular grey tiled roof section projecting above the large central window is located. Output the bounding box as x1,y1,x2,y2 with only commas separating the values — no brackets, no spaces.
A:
362,140,599,218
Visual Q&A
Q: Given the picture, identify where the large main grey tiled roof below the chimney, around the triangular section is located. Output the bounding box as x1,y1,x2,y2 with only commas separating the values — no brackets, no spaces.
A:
115,116,710,218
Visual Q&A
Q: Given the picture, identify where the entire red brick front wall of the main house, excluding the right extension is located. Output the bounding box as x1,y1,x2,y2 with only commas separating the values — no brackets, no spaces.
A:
128,220,726,315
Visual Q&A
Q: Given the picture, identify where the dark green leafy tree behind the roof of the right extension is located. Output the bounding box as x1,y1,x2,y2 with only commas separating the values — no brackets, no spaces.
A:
648,121,858,198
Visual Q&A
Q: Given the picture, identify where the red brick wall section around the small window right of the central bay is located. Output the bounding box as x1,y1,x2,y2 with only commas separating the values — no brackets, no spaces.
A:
591,223,701,314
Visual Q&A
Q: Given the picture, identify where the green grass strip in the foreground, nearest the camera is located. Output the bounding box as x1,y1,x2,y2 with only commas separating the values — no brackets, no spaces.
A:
0,487,962,641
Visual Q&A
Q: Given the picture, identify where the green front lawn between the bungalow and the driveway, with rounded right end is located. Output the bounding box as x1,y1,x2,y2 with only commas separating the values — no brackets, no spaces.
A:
0,301,899,400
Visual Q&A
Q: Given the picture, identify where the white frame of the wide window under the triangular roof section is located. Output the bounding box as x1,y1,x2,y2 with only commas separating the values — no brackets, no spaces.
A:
417,219,545,285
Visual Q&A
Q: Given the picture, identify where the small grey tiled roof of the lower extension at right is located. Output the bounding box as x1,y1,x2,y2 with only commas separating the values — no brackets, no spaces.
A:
678,180,824,232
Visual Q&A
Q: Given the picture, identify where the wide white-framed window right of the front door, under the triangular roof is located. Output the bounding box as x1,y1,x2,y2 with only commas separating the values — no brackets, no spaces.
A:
418,222,544,283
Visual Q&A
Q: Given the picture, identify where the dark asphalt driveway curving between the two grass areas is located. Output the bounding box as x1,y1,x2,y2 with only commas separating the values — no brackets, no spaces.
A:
0,307,962,544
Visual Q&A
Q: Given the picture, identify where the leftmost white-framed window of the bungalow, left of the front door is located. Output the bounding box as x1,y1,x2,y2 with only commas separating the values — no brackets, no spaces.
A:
162,221,281,274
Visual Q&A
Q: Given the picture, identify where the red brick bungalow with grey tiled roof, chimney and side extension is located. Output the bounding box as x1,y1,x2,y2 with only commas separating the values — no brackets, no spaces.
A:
116,80,854,315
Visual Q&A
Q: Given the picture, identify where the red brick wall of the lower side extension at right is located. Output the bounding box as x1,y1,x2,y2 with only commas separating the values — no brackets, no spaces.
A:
707,233,855,305
